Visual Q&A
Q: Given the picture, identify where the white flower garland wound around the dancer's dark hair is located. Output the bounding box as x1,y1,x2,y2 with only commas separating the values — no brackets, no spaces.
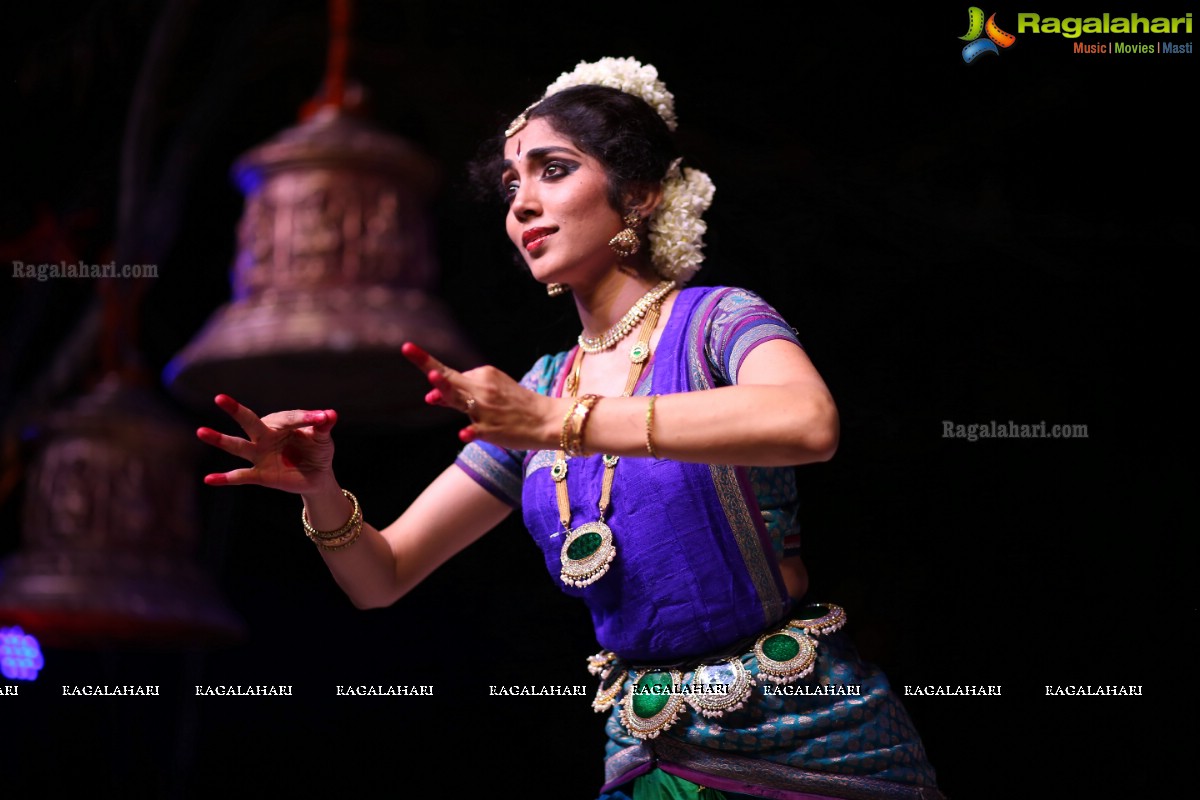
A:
525,58,715,283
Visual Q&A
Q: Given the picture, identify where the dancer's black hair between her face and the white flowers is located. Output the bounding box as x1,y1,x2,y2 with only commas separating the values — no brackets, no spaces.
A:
470,84,678,212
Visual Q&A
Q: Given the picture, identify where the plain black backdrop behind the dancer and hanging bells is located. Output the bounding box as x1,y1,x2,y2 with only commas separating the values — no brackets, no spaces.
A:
0,0,1198,800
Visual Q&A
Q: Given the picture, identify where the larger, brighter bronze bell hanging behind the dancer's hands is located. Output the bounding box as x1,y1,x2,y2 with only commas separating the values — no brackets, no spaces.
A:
164,106,478,427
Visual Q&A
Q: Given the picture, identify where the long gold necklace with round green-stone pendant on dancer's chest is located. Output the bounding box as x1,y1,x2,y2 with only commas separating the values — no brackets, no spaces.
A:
550,295,665,587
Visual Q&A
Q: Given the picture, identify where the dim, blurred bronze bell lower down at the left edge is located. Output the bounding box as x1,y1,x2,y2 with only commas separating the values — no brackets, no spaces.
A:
0,373,246,648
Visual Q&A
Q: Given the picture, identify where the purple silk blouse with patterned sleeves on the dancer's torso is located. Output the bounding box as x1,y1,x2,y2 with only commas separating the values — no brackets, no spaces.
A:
456,287,798,663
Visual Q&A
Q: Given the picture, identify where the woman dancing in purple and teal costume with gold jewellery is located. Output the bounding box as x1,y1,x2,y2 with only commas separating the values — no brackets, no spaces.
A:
199,59,941,800
